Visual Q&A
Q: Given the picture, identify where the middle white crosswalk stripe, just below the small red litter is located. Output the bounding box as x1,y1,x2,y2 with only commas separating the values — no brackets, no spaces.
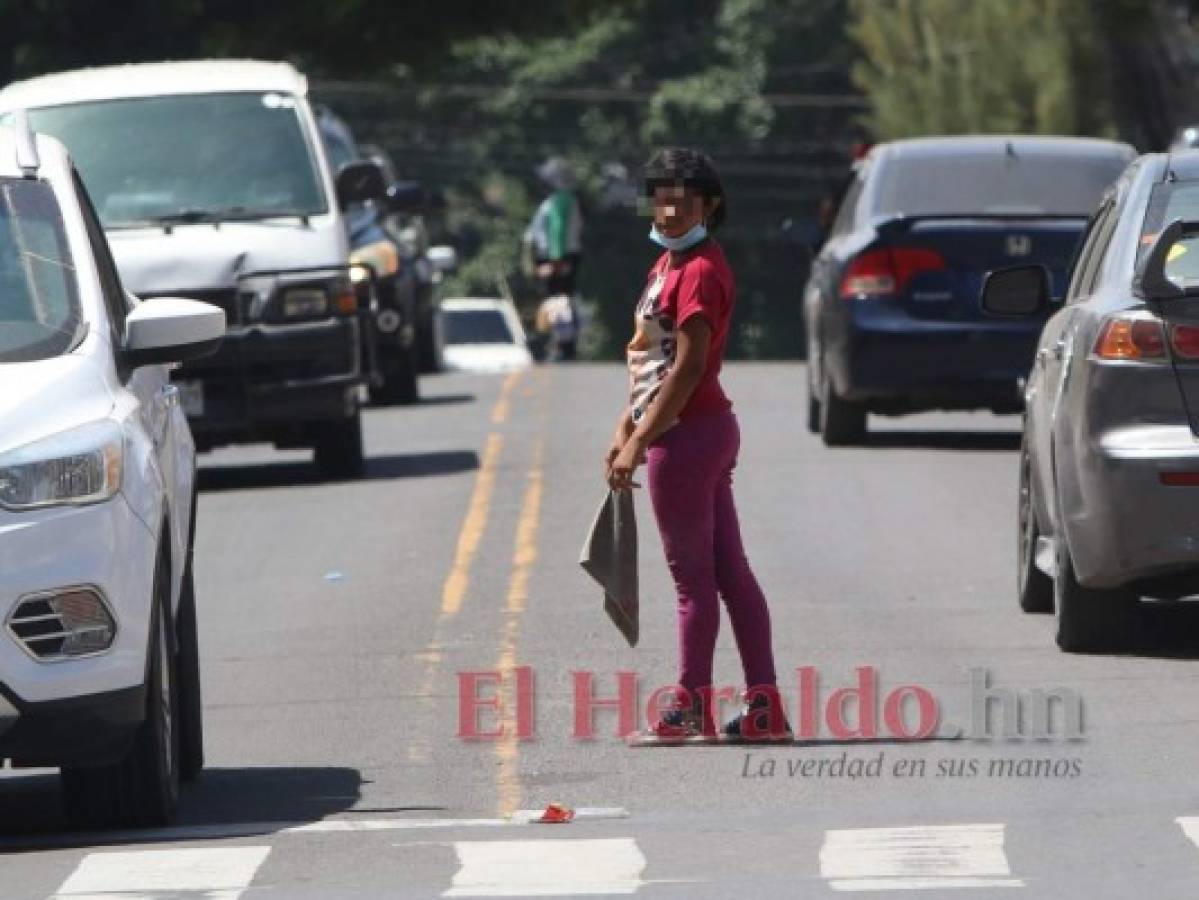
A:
442,838,645,896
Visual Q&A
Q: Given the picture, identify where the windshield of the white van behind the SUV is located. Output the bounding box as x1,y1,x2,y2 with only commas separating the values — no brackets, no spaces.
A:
29,93,327,226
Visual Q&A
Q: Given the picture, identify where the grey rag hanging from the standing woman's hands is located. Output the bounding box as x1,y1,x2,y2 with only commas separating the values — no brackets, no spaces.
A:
579,490,639,647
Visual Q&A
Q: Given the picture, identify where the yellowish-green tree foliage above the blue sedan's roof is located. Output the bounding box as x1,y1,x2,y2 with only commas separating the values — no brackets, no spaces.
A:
850,0,1150,139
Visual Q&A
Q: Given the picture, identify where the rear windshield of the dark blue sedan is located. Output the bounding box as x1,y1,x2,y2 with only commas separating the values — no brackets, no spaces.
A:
872,152,1128,216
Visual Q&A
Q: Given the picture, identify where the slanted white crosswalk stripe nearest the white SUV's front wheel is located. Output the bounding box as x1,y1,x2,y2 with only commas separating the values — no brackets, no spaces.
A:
54,847,271,900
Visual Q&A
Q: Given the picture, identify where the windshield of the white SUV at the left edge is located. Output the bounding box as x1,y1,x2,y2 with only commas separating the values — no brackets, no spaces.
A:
0,179,83,363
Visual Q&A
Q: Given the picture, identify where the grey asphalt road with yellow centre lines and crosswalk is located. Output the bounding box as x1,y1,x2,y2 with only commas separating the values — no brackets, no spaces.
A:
0,364,1199,900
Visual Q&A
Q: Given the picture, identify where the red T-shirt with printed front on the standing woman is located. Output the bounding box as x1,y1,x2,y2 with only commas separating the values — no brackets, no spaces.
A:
626,240,734,424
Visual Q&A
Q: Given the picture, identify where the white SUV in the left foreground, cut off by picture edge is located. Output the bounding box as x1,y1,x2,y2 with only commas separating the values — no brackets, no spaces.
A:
0,114,225,826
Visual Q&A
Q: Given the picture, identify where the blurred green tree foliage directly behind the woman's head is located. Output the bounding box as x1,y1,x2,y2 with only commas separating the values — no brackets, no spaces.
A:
342,0,856,357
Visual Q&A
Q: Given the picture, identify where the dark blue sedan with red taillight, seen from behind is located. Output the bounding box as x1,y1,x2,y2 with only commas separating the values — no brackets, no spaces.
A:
803,135,1135,446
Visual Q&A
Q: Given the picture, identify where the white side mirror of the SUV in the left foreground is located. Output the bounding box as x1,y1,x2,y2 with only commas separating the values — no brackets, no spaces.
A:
121,297,225,368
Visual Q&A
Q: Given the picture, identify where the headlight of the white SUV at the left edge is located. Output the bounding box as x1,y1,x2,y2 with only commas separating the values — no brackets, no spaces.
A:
0,419,125,511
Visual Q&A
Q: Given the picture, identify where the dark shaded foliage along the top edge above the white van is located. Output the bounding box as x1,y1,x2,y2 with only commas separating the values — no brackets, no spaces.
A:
0,0,628,81
